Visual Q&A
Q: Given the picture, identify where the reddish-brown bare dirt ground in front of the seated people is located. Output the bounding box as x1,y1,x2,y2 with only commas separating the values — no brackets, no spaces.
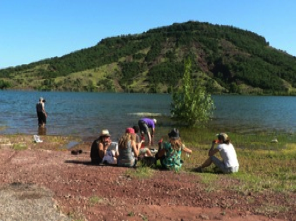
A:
0,135,296,221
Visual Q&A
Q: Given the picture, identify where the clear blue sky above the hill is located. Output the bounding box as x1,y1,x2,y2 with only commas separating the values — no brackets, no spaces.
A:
0,0,296,69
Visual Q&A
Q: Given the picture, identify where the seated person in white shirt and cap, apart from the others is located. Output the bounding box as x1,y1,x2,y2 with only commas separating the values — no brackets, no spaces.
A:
196,133,239,174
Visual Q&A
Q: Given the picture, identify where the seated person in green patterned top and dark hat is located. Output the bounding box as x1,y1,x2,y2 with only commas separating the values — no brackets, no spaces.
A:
155,129,192,171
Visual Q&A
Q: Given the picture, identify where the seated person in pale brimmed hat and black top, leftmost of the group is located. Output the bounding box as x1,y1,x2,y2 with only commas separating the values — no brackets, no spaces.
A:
90,130,118,165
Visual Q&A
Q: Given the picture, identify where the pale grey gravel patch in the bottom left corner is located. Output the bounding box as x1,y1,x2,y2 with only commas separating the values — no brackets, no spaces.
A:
0,183,71,221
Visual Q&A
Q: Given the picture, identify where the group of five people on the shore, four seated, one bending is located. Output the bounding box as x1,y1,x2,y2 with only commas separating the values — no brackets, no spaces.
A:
90,118,239,174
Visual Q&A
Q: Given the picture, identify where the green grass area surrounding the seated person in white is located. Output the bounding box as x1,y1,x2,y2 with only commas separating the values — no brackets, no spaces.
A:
176,128,296,192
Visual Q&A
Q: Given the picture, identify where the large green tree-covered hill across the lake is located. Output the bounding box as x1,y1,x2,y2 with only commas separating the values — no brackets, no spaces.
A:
0,22,296,94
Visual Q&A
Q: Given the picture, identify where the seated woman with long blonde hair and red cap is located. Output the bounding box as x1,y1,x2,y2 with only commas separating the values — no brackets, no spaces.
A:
117,129,140,167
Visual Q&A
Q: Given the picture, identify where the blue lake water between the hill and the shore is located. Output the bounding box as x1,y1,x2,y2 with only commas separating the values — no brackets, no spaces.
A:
0,91,296,140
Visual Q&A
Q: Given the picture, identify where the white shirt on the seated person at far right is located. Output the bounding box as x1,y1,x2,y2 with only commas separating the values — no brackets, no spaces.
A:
217,143,239,167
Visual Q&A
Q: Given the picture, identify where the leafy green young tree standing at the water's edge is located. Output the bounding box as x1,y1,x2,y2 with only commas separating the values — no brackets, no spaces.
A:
171,59,214,126
